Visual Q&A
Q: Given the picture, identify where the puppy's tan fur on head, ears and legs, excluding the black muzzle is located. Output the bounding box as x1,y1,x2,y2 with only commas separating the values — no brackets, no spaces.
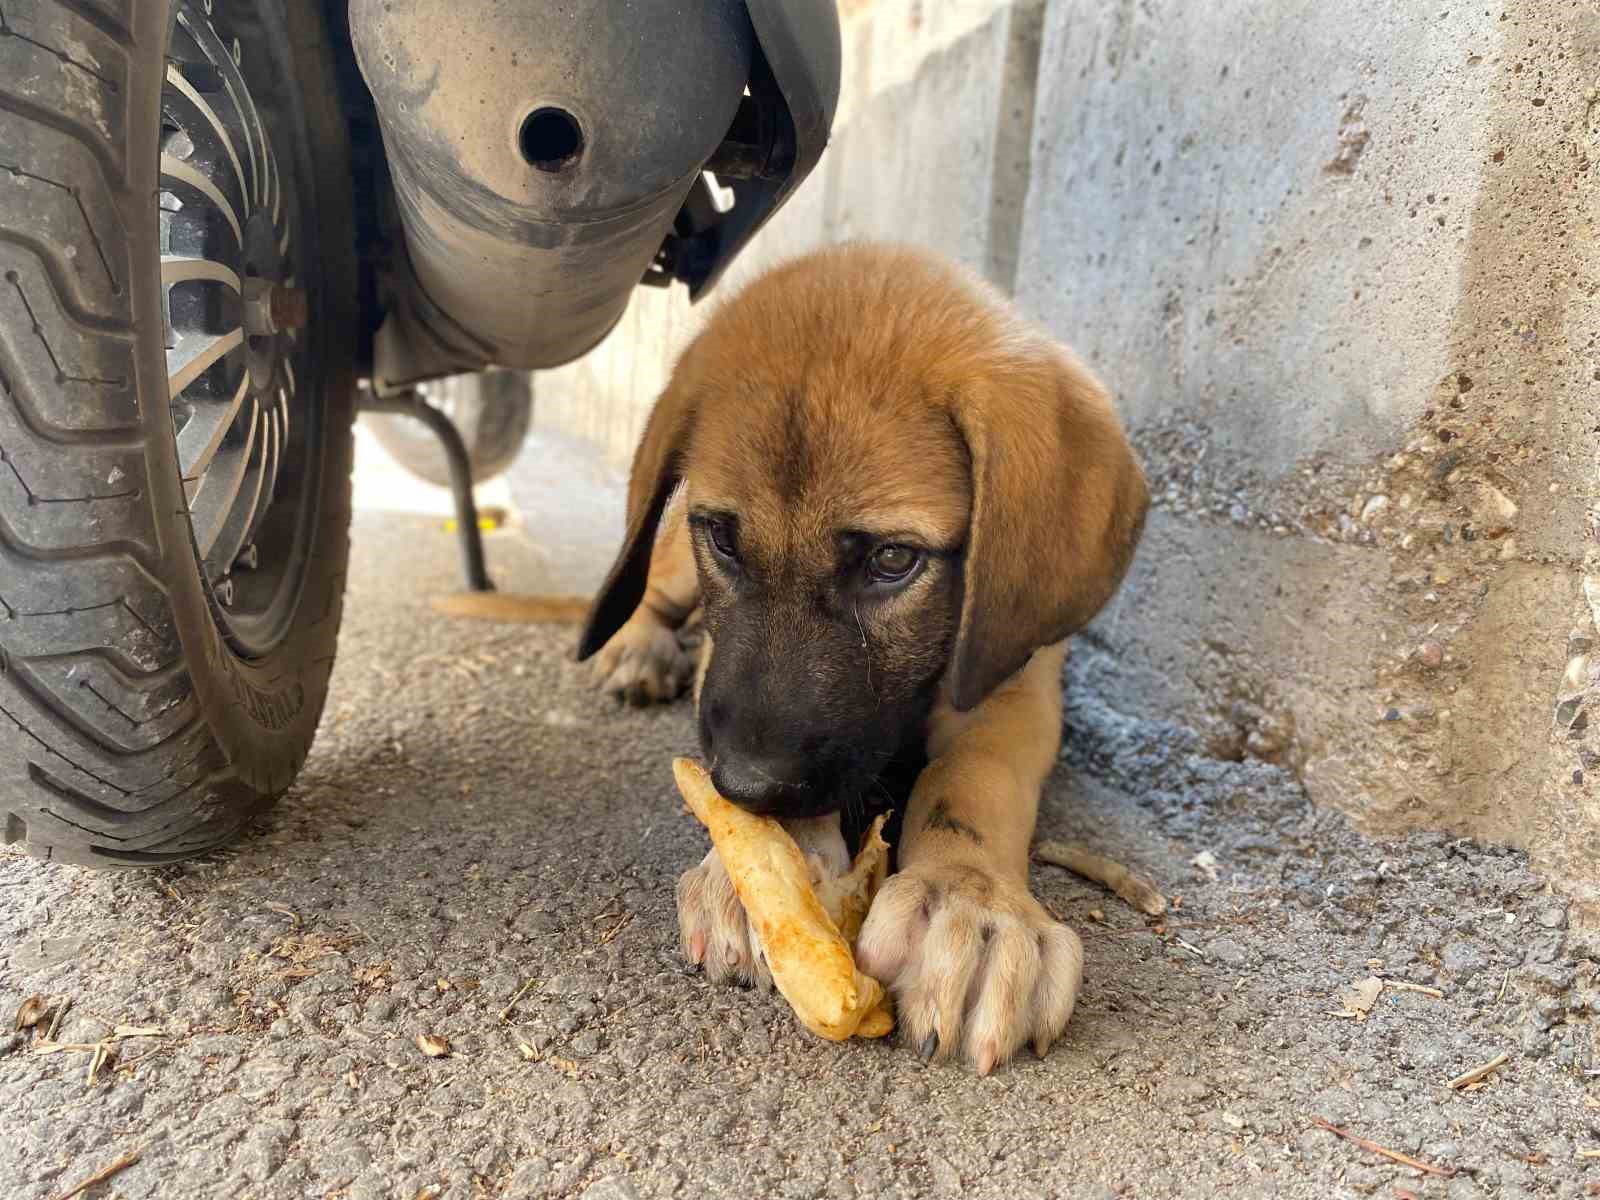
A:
584,245,1147,1072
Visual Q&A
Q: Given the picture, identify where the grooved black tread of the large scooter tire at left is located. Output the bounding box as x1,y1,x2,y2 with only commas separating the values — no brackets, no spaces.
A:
0,0,261,866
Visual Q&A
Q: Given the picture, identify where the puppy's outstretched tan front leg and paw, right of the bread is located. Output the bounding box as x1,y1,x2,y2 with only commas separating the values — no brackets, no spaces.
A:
858,642,1083,1074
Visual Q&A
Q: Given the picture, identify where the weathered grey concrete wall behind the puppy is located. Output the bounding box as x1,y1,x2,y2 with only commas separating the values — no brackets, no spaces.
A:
538,0,1600,906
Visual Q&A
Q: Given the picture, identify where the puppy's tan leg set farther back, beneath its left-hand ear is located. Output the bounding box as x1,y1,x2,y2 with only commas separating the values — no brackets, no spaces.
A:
592,496,699,704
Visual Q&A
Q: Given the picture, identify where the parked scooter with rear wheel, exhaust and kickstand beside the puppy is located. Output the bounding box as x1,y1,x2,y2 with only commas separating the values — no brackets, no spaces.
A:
0,0,840,866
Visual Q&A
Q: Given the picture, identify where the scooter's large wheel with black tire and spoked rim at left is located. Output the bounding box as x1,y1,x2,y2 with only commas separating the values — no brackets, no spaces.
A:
0,0,358,867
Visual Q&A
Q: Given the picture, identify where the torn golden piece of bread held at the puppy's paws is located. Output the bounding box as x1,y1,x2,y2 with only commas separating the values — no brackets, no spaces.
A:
672,758,894,1042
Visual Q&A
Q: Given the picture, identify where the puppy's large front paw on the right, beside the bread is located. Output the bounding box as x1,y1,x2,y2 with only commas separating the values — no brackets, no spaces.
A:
856,864,1083,1075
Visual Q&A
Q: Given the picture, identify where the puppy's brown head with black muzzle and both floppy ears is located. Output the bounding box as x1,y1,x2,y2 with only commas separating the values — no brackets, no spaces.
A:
579,246,1147,816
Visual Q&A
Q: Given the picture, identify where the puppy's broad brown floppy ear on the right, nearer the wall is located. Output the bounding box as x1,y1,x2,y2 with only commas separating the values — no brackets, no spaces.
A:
950,339,1149,712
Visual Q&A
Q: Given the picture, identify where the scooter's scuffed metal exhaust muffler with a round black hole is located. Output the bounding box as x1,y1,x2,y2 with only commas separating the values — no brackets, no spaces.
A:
350,0,754,394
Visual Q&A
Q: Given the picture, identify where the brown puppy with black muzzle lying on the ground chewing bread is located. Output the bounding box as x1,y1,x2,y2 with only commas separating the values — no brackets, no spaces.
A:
581,245,1147,1072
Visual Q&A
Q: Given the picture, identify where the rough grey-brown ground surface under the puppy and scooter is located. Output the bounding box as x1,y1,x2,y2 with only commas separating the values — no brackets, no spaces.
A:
0,446,1600,1200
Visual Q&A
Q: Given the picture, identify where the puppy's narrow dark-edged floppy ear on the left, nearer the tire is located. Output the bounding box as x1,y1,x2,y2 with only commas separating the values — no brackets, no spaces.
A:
578,373,694,662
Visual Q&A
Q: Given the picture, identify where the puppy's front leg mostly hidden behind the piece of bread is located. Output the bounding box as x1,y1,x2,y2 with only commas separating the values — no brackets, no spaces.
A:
678,813,850,989
